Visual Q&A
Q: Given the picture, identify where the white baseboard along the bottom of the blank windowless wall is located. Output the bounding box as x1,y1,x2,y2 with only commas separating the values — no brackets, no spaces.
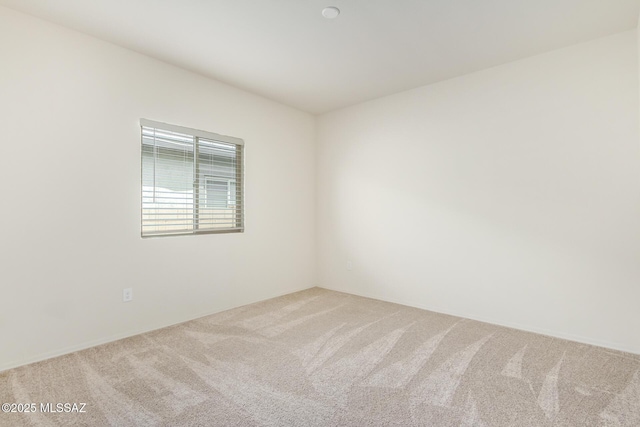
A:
318,285,640,355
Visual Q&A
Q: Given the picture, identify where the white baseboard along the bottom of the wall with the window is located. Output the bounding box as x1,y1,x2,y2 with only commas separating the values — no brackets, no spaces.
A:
0,286,315,373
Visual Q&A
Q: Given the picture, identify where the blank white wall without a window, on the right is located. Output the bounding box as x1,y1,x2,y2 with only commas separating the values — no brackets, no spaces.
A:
317,31,640,353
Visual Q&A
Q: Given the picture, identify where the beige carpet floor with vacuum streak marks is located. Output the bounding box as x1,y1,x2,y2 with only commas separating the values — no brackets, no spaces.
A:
0,288,640,427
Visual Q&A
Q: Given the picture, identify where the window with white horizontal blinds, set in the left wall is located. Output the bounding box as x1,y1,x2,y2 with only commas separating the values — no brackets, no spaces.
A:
140,119,244,237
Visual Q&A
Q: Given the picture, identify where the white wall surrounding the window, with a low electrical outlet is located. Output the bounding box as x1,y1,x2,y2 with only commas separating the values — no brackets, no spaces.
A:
0,8,315,370
